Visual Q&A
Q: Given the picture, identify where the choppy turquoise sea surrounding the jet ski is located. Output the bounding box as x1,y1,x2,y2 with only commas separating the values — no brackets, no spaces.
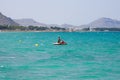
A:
0,32,120,80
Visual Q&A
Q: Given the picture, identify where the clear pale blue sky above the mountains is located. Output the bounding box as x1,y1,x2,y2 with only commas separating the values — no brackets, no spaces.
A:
0,0,120,26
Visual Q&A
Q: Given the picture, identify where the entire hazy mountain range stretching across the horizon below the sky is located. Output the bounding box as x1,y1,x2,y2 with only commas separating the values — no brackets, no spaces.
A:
0,13,120,29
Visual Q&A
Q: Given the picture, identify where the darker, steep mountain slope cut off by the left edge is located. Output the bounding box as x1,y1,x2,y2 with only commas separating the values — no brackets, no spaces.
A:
0,13,19,26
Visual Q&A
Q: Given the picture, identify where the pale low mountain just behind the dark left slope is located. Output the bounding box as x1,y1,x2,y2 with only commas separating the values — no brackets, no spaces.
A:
14,18,47,26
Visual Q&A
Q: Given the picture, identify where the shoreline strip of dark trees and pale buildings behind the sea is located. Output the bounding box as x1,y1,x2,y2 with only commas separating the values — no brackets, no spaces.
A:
0,25,120,32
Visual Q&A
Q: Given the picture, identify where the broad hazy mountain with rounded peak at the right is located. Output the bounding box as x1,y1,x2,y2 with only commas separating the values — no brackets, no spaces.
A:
79,17,120,28
